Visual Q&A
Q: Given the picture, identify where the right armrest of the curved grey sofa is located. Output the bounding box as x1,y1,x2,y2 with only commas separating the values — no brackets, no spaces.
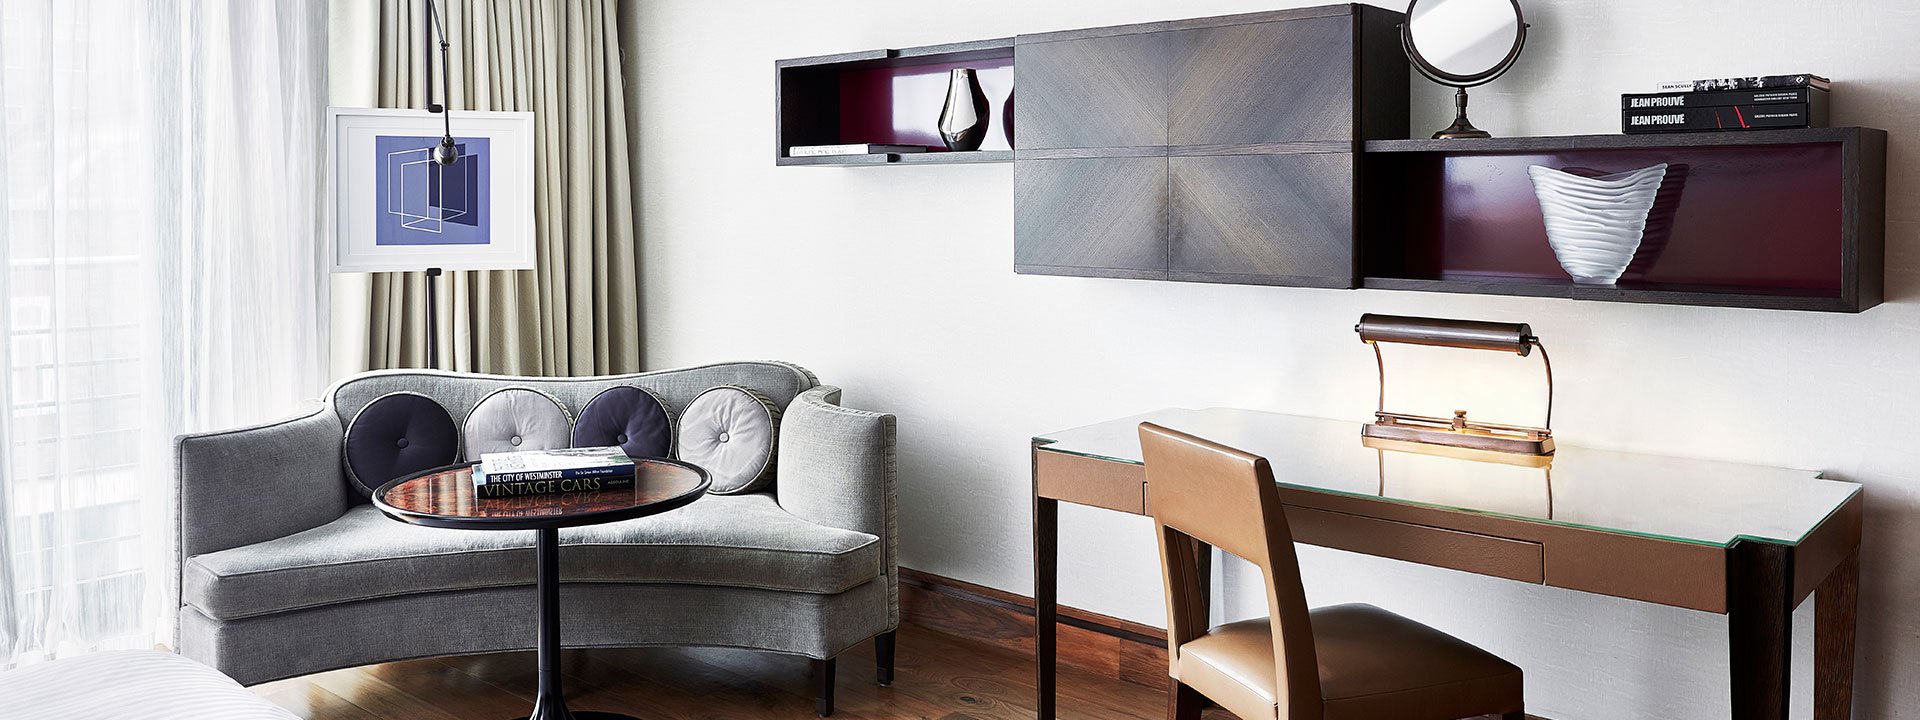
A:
774,386,899,616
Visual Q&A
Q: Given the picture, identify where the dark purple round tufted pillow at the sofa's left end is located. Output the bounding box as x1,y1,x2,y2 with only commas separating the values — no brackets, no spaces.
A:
344,392,461,497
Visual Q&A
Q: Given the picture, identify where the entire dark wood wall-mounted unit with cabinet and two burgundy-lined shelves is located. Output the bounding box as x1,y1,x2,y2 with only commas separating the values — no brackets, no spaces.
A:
774,6,1887,313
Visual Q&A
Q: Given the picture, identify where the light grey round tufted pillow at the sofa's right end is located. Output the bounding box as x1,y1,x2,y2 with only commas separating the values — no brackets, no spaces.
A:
678,386,780,495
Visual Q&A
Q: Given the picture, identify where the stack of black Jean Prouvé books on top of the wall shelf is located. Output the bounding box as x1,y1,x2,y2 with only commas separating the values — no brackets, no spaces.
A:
1620,73,1832,134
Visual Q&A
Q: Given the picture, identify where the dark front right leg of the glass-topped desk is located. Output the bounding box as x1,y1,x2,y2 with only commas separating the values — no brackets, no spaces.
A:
1726,540,1793,720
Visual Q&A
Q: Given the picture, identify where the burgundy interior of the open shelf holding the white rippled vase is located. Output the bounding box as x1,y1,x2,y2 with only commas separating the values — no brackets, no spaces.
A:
1365,142,1845,298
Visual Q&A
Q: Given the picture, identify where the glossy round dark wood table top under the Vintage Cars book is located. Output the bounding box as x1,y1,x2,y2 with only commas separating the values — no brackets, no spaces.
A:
372,457,708,530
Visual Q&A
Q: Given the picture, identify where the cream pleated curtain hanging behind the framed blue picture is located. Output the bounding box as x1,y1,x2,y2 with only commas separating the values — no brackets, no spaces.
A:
330,0,639,374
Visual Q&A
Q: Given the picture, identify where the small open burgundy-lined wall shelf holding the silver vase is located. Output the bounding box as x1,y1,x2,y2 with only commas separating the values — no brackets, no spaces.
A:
774,38,1014,165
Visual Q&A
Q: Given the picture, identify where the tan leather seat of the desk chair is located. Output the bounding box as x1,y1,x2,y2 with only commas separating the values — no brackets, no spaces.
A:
1179,605,1523,720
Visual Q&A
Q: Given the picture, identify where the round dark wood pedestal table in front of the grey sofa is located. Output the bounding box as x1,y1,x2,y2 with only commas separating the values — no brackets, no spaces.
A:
372,457,708,720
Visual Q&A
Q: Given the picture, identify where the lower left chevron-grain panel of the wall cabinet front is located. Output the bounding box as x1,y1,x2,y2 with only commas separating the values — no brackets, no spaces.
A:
1014,157,1167,280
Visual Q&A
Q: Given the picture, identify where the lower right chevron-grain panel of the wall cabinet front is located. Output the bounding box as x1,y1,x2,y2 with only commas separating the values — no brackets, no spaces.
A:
1167,154,1356,288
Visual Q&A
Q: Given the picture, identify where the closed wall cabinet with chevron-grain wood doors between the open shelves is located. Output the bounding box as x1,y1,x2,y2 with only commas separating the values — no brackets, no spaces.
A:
1014,6,1407,288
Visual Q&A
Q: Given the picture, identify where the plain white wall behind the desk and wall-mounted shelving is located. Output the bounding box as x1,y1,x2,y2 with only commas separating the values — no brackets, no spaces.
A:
630,0,1920,720
